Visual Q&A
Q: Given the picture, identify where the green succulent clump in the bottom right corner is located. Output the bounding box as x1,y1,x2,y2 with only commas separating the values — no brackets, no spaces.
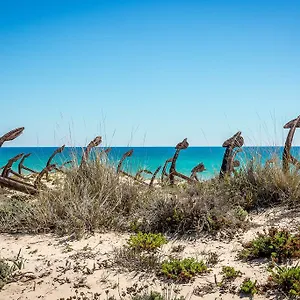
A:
268,265,300,297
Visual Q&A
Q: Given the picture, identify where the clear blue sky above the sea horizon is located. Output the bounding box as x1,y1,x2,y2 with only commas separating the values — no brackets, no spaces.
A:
0,0,300,146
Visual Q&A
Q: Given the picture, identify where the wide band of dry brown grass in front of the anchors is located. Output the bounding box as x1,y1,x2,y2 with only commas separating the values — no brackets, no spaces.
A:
0,158,300,236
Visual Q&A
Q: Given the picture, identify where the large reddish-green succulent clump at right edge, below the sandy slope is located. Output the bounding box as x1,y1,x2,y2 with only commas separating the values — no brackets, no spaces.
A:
239,227,300,261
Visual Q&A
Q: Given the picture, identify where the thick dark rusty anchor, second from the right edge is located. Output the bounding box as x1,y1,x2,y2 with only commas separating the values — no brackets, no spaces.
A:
220,131,244,178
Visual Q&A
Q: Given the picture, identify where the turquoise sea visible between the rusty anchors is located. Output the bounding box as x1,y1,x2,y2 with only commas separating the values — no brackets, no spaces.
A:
0,147,300,179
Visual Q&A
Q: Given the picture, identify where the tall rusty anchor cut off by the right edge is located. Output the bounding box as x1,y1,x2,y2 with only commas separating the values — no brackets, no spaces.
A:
282,116,300,173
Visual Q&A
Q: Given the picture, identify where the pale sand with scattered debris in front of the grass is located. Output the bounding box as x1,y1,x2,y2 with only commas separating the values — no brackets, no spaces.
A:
0,209,300,300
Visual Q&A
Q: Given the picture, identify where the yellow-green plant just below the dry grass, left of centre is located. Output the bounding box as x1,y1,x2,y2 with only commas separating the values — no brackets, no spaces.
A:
128,232,167,251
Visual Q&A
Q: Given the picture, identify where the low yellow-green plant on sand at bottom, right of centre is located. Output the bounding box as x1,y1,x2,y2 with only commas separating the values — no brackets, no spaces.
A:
160,258,208,282
